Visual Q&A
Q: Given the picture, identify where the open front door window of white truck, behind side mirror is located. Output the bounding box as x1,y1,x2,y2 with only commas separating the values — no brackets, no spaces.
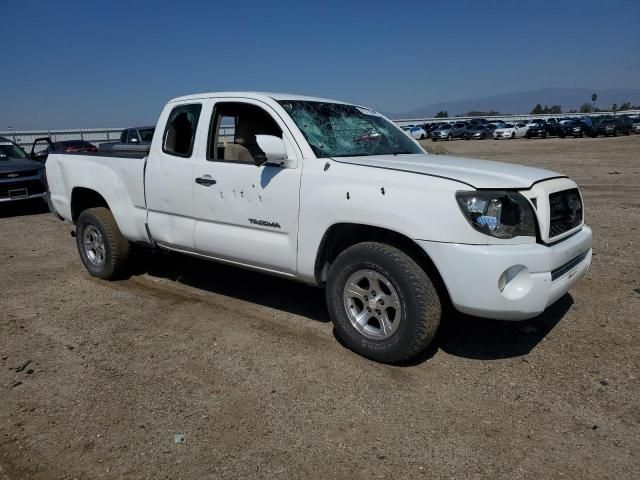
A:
207,102,282,165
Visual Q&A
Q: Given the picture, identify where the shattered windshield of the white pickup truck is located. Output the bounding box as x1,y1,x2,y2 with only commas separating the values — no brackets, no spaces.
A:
279,100,424,158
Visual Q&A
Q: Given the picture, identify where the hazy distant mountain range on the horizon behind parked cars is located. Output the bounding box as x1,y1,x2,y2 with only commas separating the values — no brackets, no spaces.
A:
389,88,640,118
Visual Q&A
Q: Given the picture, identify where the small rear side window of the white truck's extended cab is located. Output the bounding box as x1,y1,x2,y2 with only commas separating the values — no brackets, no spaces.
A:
162,103,202,158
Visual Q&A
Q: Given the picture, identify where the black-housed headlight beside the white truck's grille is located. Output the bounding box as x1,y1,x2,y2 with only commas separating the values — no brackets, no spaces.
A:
456,190,536,238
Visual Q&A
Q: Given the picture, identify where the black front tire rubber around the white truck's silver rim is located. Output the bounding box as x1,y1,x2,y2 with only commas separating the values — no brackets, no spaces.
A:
326,242,443,363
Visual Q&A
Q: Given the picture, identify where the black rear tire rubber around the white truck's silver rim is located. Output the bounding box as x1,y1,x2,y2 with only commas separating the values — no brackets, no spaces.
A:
76,207,131,280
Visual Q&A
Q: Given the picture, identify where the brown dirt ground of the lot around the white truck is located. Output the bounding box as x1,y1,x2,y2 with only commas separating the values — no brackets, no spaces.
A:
0,135,640,480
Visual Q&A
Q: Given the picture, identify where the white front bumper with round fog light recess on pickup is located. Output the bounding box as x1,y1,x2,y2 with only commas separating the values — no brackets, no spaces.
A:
418,225,592,320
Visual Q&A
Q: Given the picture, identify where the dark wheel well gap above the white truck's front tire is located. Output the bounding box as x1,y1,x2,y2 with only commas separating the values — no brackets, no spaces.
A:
315,223,449,300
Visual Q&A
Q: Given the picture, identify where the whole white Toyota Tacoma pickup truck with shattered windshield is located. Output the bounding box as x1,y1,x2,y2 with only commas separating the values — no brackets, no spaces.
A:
47,92,592,362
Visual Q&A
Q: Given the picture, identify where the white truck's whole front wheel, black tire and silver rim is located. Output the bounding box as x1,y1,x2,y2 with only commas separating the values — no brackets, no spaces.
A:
326,242,442,363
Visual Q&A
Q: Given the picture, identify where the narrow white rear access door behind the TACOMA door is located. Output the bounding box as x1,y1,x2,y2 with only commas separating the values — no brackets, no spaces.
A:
145,101,207,251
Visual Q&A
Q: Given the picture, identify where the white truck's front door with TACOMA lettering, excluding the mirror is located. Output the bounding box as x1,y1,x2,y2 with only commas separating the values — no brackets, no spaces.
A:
192,98,302,274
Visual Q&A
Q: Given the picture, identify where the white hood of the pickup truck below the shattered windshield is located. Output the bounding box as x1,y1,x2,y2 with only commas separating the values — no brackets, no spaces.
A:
333,154,565,189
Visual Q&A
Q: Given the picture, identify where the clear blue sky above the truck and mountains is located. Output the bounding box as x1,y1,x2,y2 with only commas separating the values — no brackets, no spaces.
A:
0,0,640,130
